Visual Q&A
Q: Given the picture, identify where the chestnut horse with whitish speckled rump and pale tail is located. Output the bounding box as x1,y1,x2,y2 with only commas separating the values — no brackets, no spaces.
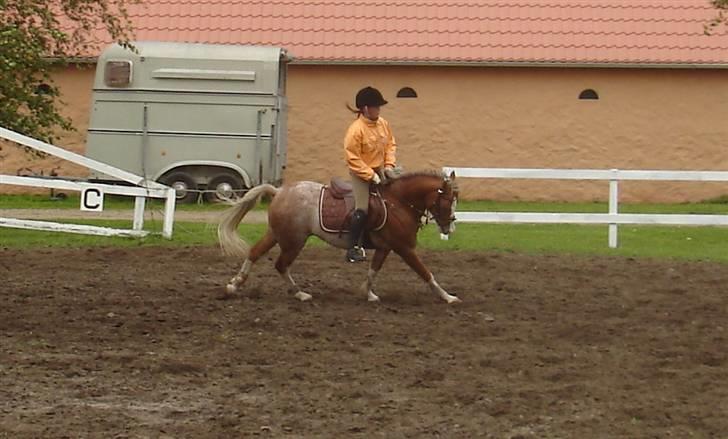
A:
217,171,460,304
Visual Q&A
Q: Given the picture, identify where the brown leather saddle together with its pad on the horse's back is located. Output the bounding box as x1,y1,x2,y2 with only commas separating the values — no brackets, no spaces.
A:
319,177,387,241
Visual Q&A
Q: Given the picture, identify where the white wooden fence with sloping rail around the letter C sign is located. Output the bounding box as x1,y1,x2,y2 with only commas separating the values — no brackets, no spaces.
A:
0,127,176,238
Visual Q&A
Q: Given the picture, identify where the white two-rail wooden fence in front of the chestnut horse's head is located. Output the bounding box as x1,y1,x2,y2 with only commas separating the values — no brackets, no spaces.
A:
443,167,728,248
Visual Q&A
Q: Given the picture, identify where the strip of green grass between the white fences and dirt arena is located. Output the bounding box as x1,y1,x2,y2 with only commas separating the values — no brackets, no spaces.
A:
0,217,728,263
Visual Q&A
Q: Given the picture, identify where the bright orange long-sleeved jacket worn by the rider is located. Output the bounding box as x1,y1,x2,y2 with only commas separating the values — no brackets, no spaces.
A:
344,116,397,181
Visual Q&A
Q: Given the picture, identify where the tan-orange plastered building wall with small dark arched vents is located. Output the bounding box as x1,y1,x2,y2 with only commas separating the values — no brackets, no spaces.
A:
0,65,728,202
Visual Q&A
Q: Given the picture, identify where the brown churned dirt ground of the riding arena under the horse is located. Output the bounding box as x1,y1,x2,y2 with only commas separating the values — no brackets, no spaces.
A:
0,247,728,438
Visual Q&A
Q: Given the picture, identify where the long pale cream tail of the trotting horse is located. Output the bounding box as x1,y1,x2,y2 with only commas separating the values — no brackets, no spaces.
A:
217,184,279,259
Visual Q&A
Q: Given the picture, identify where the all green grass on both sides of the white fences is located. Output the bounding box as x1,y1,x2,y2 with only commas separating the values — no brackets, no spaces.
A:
0,195,728,262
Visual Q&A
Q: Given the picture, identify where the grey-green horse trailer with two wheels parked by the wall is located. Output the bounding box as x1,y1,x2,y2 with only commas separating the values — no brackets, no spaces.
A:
86,42,292,202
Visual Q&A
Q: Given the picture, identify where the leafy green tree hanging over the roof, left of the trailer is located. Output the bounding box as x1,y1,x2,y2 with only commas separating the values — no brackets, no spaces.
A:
0,0,138,142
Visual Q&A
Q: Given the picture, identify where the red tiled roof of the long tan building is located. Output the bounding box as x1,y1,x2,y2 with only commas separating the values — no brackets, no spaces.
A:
79,0,728,65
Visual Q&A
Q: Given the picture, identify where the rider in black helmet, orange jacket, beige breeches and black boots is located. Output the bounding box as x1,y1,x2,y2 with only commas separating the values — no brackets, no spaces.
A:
344,87,397,262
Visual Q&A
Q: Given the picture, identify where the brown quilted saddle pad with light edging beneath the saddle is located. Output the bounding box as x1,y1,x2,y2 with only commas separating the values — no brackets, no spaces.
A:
319,186,387,233
